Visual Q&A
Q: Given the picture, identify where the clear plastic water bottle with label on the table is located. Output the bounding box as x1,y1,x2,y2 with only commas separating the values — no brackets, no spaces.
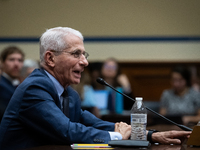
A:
131,97,147,140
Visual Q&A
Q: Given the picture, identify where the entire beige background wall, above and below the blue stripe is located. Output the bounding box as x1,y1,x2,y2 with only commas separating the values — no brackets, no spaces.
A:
0,0,200,62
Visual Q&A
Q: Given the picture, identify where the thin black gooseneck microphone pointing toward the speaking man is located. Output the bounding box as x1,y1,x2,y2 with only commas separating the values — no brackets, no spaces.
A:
96,78,192,131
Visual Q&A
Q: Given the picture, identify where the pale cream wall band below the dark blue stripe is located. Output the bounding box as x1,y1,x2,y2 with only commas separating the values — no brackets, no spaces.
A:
0,42,200,62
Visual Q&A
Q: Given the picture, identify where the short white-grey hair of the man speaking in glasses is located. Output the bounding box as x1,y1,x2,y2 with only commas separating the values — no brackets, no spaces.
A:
40,27,83,62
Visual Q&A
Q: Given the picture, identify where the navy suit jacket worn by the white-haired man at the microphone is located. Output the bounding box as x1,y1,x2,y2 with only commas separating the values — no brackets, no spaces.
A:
0,69,114,150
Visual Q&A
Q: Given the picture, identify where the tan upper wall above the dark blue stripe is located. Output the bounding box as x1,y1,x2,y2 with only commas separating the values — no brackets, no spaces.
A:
0,0,200,37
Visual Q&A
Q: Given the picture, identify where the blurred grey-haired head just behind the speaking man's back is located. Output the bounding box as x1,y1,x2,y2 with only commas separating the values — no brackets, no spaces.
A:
20,59,39,82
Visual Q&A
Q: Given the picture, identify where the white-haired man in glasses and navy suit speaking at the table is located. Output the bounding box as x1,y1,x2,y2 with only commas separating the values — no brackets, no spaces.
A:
0,27,191,150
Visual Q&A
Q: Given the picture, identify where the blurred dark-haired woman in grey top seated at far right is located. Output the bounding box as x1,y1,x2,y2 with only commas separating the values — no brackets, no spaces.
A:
160,66,200,125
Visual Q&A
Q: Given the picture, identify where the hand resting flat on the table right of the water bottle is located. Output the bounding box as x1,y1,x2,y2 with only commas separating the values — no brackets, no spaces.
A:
152,131,191,144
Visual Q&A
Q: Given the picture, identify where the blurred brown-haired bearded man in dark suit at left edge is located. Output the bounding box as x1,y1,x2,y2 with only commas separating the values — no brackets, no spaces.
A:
0,46,24,121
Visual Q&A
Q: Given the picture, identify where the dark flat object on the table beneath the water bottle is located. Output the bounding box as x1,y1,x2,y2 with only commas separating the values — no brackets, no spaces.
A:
108,140,151,147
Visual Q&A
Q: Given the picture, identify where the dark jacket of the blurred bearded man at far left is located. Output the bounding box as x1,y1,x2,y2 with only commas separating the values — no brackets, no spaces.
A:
0,75,16,122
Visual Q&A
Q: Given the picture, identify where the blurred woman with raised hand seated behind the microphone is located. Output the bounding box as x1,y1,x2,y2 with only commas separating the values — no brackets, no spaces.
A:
101,58,133,112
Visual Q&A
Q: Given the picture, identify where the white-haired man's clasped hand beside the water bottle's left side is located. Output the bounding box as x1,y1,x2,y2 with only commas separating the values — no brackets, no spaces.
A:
115,122,131,140
